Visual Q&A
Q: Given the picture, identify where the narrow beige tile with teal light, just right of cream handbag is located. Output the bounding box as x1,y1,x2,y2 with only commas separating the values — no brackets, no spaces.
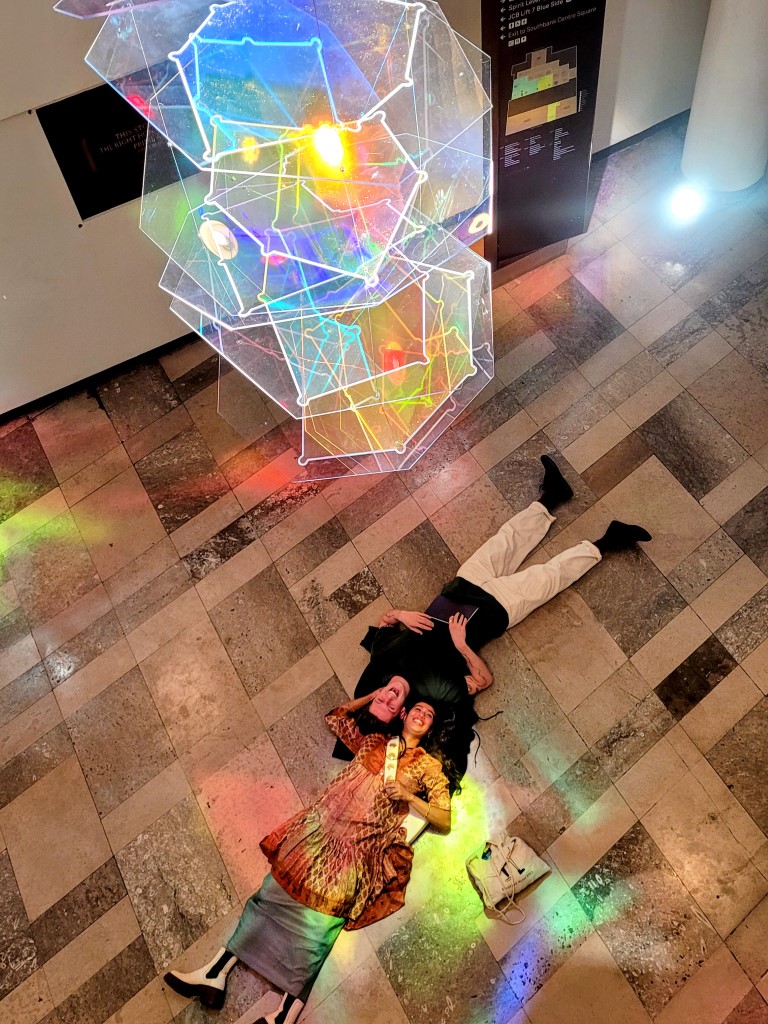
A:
549,785,637,886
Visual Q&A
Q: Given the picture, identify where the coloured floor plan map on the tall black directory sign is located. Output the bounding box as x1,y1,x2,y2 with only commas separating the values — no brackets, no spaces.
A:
506,46,579,135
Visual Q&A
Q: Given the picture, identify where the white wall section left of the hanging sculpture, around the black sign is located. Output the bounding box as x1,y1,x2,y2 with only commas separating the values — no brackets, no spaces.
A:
0,0,182,414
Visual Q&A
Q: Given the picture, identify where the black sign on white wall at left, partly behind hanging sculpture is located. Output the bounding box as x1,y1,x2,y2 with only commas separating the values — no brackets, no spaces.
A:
37,85,197,219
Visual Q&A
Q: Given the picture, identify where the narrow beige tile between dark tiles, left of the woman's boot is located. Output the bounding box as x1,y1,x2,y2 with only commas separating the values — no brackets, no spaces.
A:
44,896,141,1005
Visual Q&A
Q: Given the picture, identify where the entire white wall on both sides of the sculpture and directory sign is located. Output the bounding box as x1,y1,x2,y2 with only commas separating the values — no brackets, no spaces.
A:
0,0,710,414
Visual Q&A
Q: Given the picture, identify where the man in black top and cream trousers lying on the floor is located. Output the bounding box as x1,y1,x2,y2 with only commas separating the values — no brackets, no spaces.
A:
334,455,651,760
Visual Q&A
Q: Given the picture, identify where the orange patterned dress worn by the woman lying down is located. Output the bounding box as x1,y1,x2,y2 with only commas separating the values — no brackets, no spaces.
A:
261,709,451,930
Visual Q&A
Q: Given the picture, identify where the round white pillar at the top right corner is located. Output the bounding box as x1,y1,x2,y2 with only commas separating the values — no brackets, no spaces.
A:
682,0,768,191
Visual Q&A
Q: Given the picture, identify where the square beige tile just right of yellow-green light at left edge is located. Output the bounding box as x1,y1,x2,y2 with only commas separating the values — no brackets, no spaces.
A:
72,469,166,580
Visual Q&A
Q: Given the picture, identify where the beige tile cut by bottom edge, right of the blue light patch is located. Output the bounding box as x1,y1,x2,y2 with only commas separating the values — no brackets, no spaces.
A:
525,934,650,1024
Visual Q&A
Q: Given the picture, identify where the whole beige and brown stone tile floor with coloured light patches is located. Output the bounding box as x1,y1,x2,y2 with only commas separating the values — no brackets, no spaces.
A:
0,119,768,1024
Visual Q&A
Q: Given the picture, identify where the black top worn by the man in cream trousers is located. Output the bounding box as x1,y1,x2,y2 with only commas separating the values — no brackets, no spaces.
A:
334,577,509,761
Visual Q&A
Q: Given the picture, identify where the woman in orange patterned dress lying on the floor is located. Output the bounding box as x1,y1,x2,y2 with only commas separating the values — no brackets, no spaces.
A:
165,695,459,1024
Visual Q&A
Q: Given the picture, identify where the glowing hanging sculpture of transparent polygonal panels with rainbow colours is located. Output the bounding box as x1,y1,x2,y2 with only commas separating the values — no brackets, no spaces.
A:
59,0,493,476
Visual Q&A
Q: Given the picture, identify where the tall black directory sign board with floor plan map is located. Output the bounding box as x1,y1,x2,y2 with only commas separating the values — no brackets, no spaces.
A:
482,0,605,266
